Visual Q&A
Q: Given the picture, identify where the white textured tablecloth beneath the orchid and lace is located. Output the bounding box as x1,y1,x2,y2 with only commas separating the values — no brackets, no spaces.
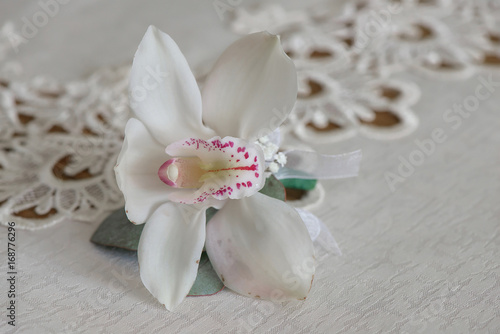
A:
0,1,500,333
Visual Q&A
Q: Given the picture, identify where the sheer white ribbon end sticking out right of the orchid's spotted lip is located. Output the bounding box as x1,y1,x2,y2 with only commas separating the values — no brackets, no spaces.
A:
275,150,362,179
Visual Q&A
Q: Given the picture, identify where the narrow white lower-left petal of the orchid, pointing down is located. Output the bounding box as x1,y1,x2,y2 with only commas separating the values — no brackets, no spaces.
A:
137,203,206,310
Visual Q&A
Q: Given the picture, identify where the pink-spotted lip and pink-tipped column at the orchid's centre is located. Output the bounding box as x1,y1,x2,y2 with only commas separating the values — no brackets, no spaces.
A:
158,137,265,204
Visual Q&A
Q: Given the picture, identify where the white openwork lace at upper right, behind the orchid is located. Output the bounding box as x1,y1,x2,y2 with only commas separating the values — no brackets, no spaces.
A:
231,0,500,143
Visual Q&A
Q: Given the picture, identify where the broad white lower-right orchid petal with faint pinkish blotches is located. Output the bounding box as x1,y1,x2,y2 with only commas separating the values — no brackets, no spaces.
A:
206,193,315,301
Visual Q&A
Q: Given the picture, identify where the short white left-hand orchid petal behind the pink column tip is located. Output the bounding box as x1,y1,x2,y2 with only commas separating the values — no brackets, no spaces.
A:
115,118,174,224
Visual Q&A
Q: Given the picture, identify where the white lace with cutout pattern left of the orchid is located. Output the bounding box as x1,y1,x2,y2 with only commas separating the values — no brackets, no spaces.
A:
0,21,129,229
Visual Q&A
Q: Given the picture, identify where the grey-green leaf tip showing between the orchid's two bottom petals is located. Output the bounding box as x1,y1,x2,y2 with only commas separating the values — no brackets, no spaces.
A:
188,252,224,296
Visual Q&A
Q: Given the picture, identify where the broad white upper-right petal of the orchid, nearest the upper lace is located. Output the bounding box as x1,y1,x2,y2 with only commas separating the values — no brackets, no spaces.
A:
202,32,297,139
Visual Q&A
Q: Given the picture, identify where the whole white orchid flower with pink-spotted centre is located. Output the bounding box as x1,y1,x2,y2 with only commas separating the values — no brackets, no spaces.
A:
115,26,315,310
